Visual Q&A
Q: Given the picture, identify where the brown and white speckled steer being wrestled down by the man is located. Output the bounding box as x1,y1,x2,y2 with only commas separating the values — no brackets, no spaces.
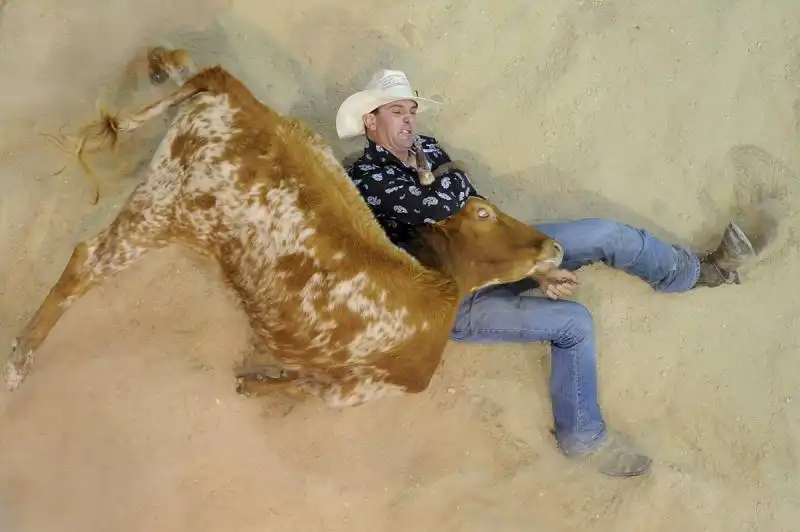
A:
6,49,563,406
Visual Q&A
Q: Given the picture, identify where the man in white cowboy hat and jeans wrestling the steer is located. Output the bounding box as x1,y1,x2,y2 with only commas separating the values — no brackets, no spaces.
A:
336,70,754,476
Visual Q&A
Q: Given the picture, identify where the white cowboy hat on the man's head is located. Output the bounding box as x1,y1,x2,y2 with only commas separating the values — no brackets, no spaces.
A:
336,69,442,139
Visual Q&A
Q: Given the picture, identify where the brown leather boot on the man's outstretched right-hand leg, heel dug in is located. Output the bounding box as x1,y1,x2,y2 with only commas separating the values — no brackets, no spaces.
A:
694,222,756,288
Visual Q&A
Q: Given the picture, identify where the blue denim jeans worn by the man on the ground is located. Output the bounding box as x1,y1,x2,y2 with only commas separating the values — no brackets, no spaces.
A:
452,219,700,455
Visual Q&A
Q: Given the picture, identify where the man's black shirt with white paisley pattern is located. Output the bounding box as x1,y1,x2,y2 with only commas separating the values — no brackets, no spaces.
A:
347,135,480,248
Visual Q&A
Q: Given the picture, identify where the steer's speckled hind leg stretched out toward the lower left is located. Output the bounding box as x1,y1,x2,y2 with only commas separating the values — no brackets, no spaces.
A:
5,189,166,390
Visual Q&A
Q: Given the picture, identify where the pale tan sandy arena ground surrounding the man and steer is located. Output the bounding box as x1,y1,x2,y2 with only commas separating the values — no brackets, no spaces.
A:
0,0,800,532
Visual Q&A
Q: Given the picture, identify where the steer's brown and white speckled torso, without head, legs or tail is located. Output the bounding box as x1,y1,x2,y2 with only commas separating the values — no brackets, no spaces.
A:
153,78,456,372
